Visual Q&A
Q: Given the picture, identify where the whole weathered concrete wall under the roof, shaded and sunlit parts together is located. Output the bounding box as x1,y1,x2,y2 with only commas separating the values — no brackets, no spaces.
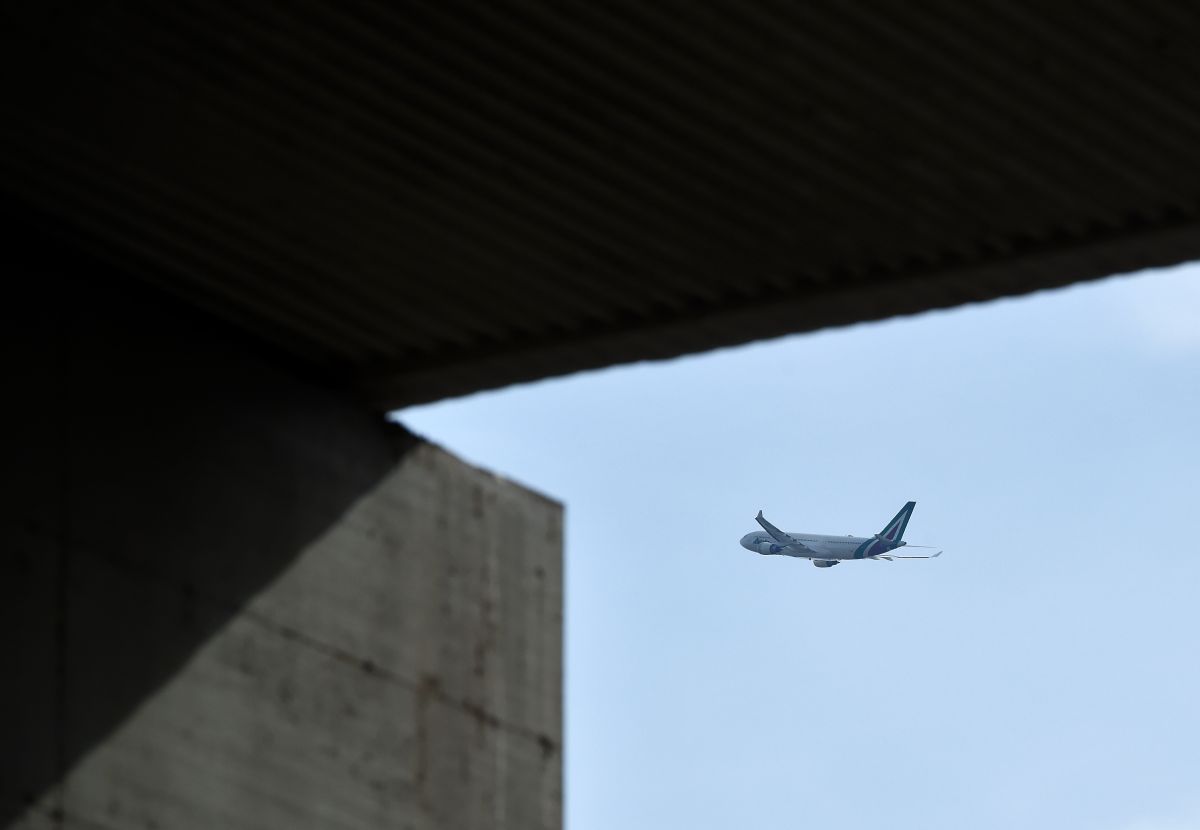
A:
0,260,562,830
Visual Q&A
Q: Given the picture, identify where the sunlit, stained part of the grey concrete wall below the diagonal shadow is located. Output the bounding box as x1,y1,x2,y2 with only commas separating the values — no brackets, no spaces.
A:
52,445,562,829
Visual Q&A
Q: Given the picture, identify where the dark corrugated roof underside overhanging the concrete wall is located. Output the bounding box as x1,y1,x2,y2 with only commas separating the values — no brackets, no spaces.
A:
0,0,1200,407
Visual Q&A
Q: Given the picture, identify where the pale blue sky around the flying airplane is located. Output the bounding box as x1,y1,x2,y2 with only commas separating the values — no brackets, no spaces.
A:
401,266,1200,830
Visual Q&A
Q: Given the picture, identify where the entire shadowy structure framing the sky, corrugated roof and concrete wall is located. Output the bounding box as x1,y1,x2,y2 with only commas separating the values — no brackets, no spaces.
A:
0,0,1200,829
